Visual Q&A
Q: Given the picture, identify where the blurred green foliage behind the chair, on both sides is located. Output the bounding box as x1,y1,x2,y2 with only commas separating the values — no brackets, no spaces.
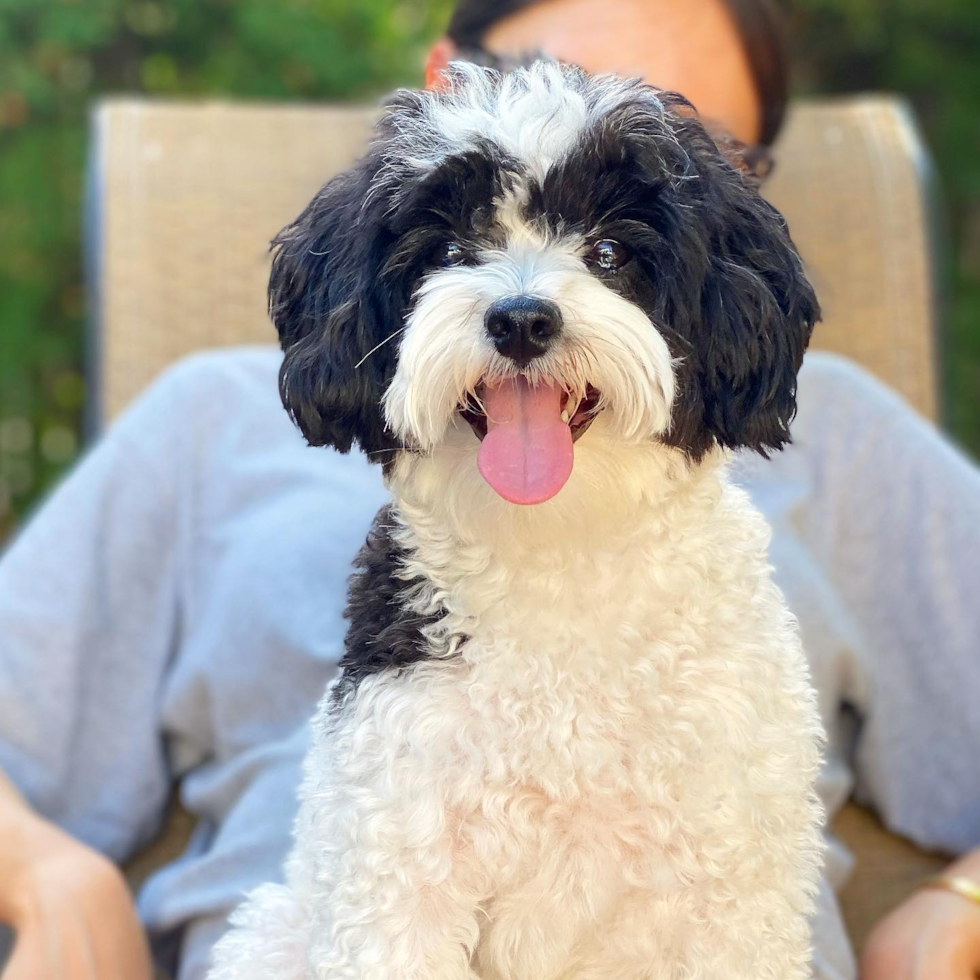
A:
0,0,980,540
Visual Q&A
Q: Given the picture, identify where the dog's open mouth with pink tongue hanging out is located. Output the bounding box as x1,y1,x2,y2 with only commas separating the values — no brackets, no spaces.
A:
459,376,601,504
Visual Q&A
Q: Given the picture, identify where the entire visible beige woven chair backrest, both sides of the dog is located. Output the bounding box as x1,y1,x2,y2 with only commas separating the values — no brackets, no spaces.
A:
93,96,936,421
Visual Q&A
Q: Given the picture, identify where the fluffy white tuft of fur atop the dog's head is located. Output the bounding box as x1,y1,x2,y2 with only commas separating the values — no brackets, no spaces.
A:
389,61,663,180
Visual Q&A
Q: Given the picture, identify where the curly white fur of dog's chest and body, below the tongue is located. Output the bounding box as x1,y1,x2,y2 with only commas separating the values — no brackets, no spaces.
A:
209,440,819,980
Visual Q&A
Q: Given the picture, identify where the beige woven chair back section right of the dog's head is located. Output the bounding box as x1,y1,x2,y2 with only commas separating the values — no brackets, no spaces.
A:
765,96,938,419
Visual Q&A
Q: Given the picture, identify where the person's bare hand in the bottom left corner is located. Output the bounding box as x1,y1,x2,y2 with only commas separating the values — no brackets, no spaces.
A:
0,814,153,980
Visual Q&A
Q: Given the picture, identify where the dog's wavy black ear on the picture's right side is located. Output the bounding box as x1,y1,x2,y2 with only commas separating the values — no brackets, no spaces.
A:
648,104,820,464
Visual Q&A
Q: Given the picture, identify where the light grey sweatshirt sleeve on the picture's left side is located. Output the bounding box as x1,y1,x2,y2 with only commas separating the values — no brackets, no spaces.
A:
0,367,201,859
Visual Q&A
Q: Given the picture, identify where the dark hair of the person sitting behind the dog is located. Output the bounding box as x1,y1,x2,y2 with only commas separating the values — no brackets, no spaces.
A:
447,0,789,146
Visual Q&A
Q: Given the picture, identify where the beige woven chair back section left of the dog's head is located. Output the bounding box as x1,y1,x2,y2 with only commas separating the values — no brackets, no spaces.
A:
91,99,374,422
